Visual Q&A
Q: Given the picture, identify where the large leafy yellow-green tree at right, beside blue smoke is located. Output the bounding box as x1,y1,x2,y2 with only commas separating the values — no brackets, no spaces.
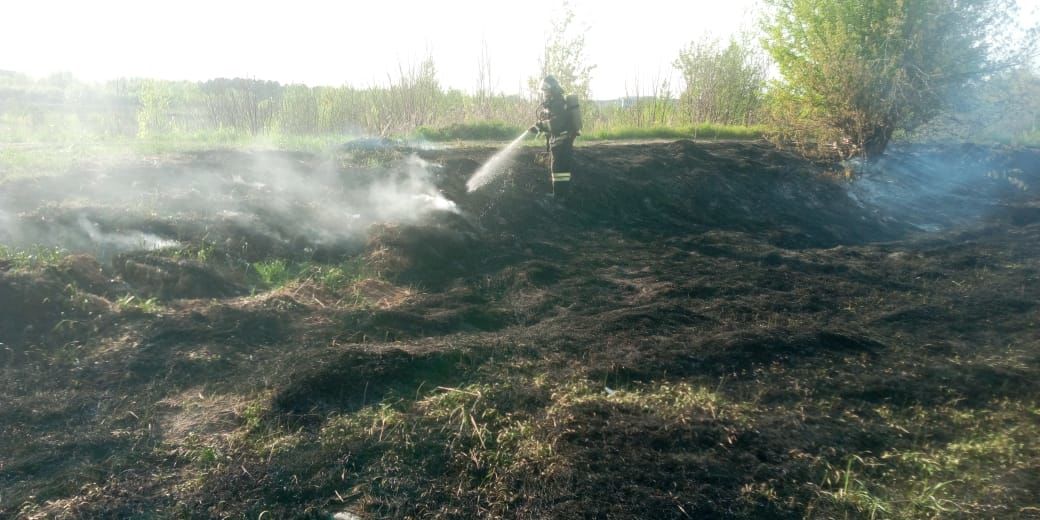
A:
764,0,1026,158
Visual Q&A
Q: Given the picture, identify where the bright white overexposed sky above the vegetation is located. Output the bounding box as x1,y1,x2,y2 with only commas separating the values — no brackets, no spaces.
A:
0,0,1040,99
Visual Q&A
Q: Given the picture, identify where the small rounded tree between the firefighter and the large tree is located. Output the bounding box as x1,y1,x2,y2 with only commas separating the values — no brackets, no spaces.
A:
674,36,769,125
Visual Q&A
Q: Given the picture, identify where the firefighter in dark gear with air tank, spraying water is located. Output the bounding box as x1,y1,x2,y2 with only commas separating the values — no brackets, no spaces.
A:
530,76,579,199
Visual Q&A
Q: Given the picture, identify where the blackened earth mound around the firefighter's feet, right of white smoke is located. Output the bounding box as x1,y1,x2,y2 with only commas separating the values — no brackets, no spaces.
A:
423,141,904,246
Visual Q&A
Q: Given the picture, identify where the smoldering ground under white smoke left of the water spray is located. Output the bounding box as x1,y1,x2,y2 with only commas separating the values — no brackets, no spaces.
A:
0,147,458,257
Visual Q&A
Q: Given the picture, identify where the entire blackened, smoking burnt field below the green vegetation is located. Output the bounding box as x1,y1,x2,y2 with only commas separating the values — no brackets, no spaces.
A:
0,141,1040,519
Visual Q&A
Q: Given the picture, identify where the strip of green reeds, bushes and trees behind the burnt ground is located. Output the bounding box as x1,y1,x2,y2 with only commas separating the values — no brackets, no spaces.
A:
0,9,1040,172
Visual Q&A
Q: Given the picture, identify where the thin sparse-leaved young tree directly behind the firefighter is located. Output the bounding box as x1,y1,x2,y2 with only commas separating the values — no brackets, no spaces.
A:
530,2,596,100
